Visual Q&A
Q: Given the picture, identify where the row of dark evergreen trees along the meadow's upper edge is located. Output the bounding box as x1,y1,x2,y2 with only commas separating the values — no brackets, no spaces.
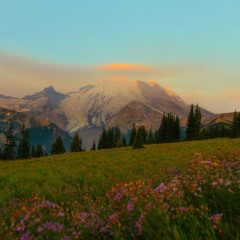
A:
0,105,240,160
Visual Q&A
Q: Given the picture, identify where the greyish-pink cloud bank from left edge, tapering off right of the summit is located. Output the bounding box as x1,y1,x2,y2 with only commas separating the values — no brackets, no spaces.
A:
0,52,188,97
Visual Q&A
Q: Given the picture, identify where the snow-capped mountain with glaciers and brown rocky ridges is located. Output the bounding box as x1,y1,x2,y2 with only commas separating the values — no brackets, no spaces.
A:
0,77,211,147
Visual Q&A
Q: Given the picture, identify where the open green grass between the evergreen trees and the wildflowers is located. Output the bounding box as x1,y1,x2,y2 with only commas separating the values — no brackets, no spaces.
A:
0,139,240,208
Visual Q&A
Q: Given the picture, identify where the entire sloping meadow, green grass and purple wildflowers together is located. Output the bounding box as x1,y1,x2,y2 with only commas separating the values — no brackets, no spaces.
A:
0,139,240,240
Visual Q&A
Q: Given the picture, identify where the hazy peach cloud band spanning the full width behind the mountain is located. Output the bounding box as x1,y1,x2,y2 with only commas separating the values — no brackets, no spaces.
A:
0,52,240,112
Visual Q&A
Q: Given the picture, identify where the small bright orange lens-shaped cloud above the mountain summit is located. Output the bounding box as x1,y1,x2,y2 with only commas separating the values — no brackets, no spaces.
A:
99,63,152,72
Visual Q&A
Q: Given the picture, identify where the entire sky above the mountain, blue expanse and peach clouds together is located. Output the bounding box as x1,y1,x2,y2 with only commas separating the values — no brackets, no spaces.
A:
0,0,240,113
